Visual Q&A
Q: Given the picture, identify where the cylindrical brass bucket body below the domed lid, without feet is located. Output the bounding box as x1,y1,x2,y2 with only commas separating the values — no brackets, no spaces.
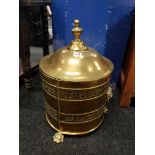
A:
40,72,110,135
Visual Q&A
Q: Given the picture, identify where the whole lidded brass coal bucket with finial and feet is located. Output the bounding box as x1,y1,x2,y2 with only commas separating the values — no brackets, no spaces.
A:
39,20,113,139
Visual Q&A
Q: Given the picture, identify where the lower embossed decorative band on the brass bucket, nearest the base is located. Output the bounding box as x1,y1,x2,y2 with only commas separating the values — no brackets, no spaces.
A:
45,101,106,123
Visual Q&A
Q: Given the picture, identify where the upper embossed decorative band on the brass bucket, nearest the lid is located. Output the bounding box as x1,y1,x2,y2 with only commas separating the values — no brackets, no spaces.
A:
42,81,109,100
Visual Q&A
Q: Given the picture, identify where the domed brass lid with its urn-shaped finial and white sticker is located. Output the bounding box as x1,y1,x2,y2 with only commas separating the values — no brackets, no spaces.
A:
39,20,113,82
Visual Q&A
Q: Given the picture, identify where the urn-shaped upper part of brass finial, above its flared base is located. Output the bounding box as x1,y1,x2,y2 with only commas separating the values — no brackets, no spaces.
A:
72,19,83,40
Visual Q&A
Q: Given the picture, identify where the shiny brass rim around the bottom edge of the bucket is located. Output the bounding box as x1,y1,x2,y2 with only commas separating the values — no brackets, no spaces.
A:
46,113,104,135
